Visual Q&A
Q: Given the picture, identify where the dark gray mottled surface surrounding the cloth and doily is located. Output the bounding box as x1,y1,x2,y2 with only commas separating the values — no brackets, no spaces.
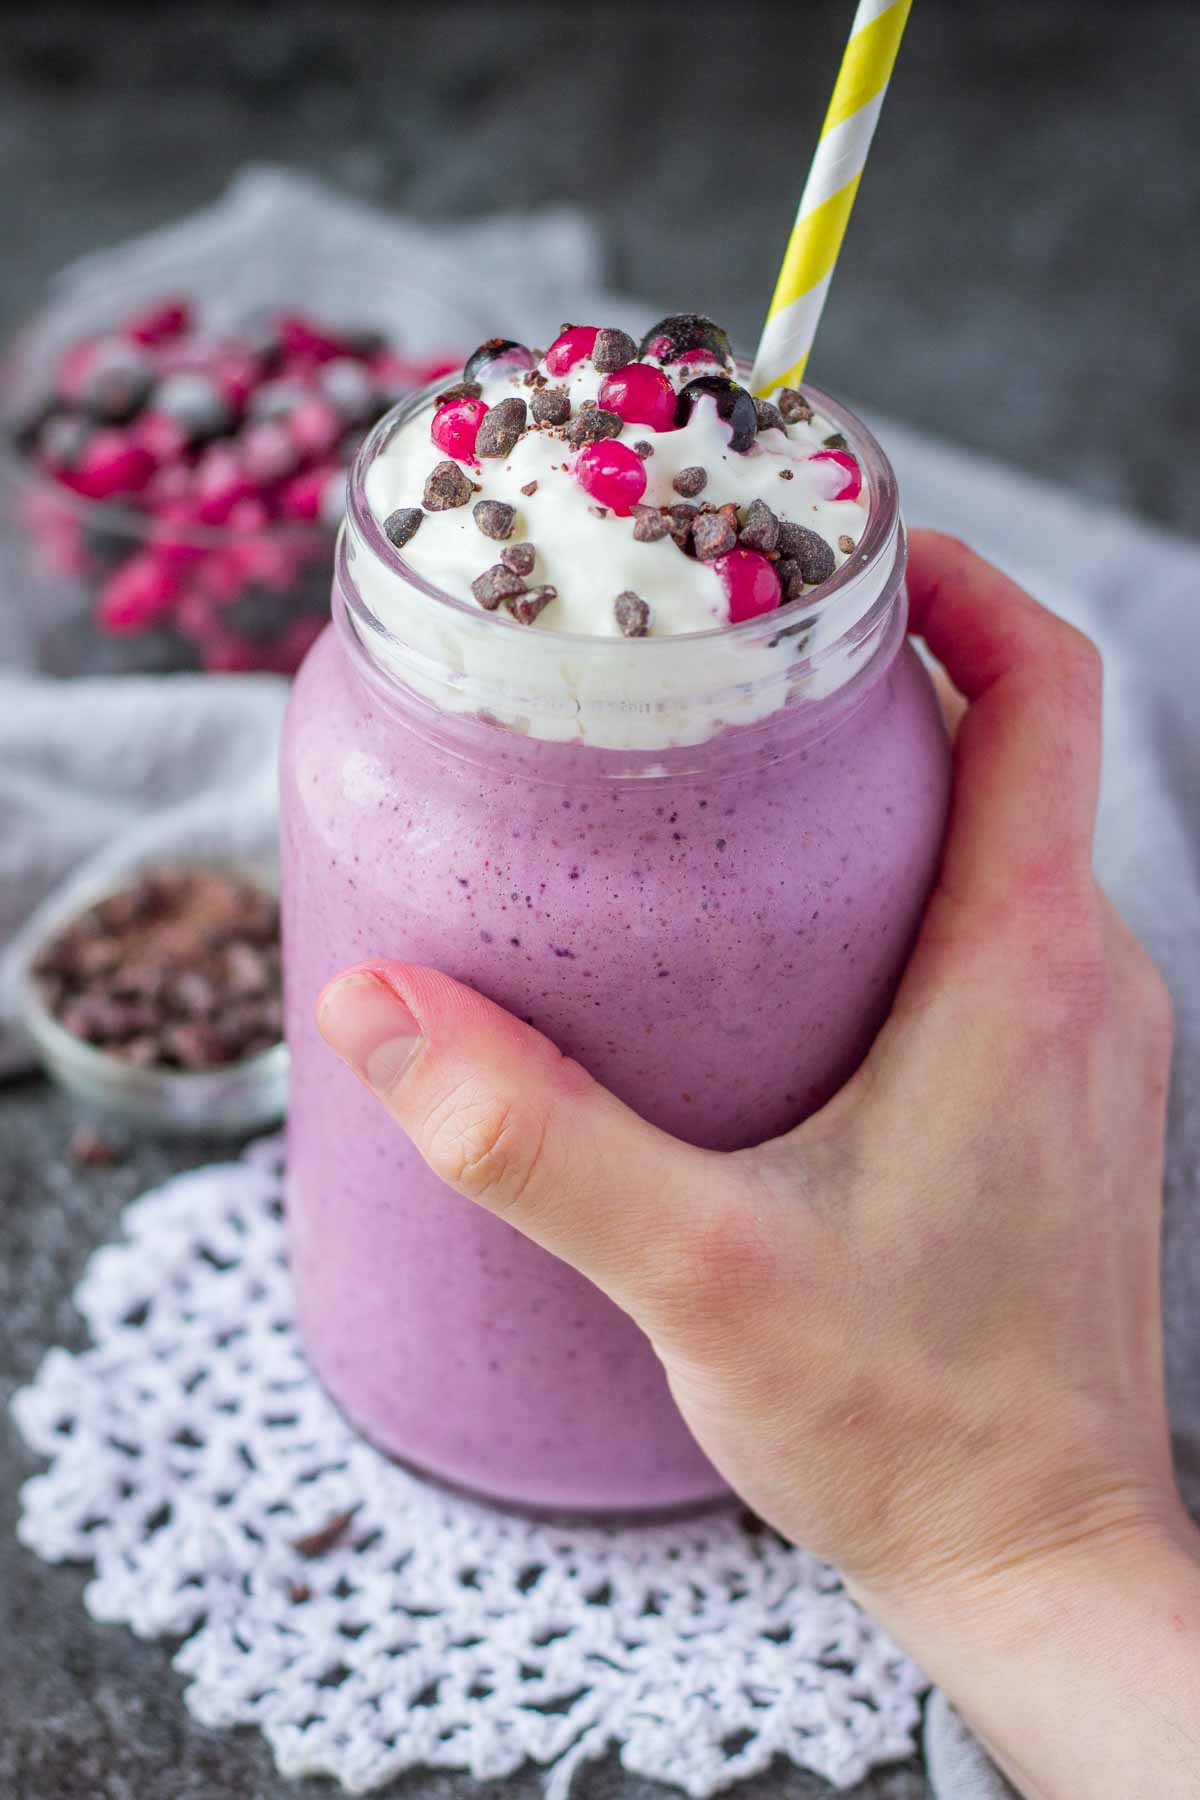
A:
0,0,1200,1800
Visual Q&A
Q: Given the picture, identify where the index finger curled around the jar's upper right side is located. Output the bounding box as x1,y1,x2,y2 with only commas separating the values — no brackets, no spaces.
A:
909,531,1101,902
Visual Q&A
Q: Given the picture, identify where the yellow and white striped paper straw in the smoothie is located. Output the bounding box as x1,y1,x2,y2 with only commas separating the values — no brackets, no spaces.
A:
750,0,912,396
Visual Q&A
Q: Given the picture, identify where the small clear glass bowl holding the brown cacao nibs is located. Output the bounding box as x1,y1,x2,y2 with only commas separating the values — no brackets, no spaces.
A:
16,864,288,1138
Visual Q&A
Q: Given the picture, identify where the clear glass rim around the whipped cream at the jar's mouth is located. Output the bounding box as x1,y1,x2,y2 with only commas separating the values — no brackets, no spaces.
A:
338,360,900,657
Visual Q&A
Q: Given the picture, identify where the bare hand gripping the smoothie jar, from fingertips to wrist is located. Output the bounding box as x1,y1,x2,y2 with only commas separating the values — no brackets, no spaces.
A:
318,533,1200,1800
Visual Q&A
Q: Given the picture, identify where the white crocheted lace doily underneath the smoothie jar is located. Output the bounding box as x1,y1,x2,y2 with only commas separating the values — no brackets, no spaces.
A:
13,1141,923,1800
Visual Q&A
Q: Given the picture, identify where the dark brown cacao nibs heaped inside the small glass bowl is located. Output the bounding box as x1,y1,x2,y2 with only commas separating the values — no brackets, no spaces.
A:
31,864,282,1073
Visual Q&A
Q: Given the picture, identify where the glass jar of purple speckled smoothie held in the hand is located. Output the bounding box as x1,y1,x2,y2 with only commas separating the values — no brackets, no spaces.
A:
282,391,948,1512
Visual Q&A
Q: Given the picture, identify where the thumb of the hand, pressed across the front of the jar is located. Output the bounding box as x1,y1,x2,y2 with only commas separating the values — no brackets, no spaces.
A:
317,961,723,1314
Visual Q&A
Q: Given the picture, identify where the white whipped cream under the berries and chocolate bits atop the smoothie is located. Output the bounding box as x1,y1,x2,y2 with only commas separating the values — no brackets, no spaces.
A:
365,338,869,637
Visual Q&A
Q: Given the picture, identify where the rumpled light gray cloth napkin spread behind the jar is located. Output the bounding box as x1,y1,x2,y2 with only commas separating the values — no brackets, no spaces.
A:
0,171,1200,1800
